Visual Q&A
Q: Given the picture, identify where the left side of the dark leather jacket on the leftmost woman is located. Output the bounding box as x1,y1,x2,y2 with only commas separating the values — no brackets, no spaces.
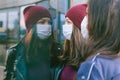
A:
4,43,27,80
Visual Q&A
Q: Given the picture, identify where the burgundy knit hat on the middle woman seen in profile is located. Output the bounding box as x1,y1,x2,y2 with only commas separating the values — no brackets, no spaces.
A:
65,4,87,28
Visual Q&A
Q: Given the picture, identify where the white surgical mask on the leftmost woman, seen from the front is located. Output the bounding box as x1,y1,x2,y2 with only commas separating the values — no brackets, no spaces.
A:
36,24,52,39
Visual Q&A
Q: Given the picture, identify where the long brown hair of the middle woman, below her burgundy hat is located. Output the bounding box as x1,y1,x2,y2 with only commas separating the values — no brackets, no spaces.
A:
61,25,83,69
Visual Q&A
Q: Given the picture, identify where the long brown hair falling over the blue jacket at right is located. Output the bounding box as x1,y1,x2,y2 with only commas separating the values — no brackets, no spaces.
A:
82,0,120,58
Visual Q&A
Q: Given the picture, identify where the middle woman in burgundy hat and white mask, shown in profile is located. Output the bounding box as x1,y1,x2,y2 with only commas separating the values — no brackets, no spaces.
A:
50,4,87,80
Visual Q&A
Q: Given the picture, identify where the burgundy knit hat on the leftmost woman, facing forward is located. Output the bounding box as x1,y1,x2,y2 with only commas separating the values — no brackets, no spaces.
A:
23,6,51,32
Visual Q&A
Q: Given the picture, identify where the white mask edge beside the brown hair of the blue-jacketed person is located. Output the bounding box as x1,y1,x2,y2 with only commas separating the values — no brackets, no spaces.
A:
81,16,89,39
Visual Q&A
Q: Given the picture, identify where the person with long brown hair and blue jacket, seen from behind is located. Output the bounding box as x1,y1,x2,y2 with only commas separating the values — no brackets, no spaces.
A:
77,0,120,80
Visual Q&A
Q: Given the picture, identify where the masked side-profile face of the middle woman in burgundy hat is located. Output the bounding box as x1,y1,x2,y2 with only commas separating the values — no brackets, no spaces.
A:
62,17,74,40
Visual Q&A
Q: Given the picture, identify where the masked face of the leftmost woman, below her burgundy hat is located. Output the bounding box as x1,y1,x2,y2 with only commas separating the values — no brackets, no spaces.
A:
36,17,52,39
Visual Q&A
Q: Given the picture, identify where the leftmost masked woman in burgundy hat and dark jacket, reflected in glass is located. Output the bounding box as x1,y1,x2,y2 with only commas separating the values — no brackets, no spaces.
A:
4,6,62,80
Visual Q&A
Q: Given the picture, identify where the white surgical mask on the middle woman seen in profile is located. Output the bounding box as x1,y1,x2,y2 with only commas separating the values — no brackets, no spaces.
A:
63,24,72,40
